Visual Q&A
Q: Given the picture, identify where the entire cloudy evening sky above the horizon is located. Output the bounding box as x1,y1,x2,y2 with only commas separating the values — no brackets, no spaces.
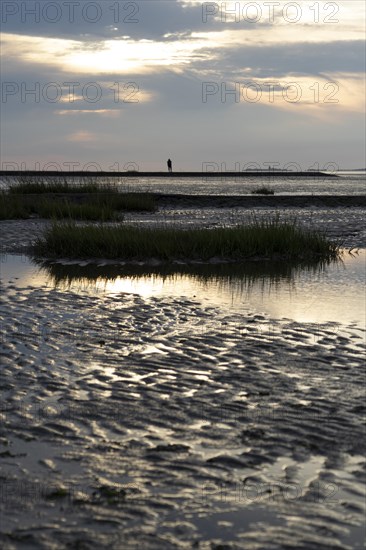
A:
0,0,366,171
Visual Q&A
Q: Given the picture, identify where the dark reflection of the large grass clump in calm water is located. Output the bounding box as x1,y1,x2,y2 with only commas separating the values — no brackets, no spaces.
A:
37,260,337,291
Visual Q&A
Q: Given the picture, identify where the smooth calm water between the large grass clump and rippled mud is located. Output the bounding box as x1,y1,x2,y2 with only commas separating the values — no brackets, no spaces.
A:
1,250,366,328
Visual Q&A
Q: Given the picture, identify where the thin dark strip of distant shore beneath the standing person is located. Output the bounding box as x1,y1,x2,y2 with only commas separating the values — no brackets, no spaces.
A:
0,170,338,179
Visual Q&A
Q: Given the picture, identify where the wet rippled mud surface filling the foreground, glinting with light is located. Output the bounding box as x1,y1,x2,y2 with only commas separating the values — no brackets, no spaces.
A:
0,252,366,550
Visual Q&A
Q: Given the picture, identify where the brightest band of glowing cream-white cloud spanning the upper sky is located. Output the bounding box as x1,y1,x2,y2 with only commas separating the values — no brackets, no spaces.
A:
2,8,364,75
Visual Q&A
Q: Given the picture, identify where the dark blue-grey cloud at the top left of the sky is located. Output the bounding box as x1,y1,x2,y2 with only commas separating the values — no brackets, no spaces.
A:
1,0,214,40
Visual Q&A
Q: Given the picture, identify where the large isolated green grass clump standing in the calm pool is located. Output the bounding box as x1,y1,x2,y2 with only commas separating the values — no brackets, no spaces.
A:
35,218,339,261
